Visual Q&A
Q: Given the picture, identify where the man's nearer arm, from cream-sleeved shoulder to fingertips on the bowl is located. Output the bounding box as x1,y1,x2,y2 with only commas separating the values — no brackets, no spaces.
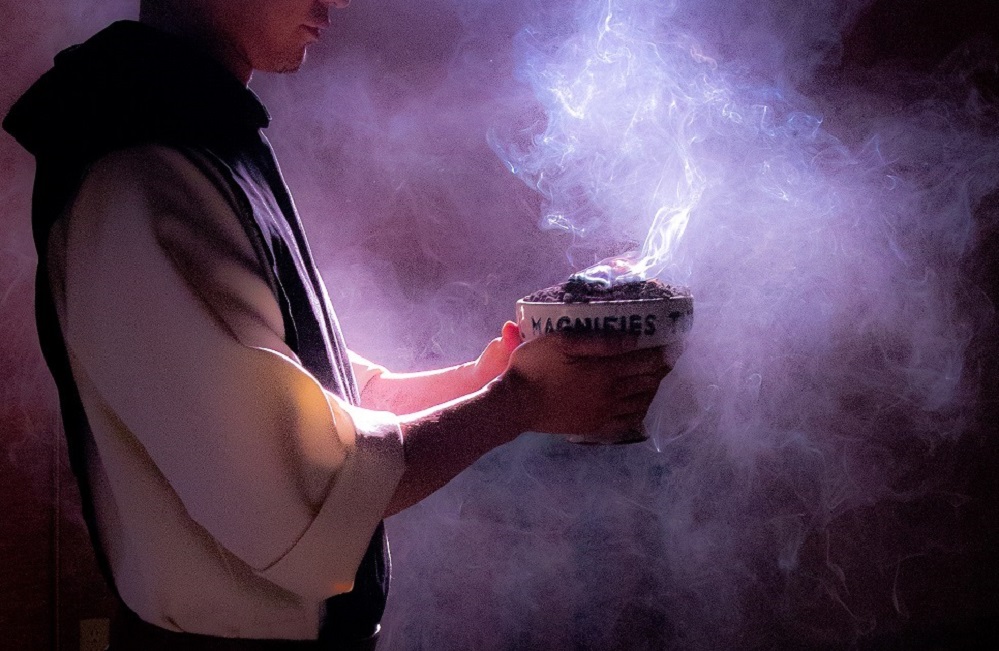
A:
63,150,668,584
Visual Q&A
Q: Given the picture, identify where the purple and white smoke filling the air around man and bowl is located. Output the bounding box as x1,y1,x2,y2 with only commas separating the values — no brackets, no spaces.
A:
0,0,999,649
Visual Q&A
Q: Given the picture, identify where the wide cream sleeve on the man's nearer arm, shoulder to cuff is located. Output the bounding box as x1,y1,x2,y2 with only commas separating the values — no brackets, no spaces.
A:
54,147,404,597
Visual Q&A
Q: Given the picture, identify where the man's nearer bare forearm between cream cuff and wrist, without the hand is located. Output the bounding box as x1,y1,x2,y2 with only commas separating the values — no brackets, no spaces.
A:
386,378,526,516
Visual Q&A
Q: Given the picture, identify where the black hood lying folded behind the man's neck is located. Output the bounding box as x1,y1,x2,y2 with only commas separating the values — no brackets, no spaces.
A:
3,21,270,165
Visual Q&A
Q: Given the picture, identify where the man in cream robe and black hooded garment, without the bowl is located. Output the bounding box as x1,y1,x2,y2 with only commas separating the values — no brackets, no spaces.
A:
5,0,669,651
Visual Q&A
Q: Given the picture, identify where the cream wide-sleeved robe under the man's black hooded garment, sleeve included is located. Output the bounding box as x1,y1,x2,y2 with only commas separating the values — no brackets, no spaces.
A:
49,146,404,639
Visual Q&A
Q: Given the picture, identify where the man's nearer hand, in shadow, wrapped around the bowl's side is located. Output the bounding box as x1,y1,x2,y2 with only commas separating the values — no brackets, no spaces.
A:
502,326,670,443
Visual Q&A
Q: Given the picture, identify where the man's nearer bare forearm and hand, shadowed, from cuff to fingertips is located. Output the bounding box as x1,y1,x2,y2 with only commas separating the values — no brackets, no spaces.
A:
386,334,670,515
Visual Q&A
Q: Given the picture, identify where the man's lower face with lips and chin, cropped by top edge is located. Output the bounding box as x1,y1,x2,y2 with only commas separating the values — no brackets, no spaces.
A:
215,0,349,72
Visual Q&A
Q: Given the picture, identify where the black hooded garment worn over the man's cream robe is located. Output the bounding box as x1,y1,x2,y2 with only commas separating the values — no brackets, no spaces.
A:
4,22,402,640
